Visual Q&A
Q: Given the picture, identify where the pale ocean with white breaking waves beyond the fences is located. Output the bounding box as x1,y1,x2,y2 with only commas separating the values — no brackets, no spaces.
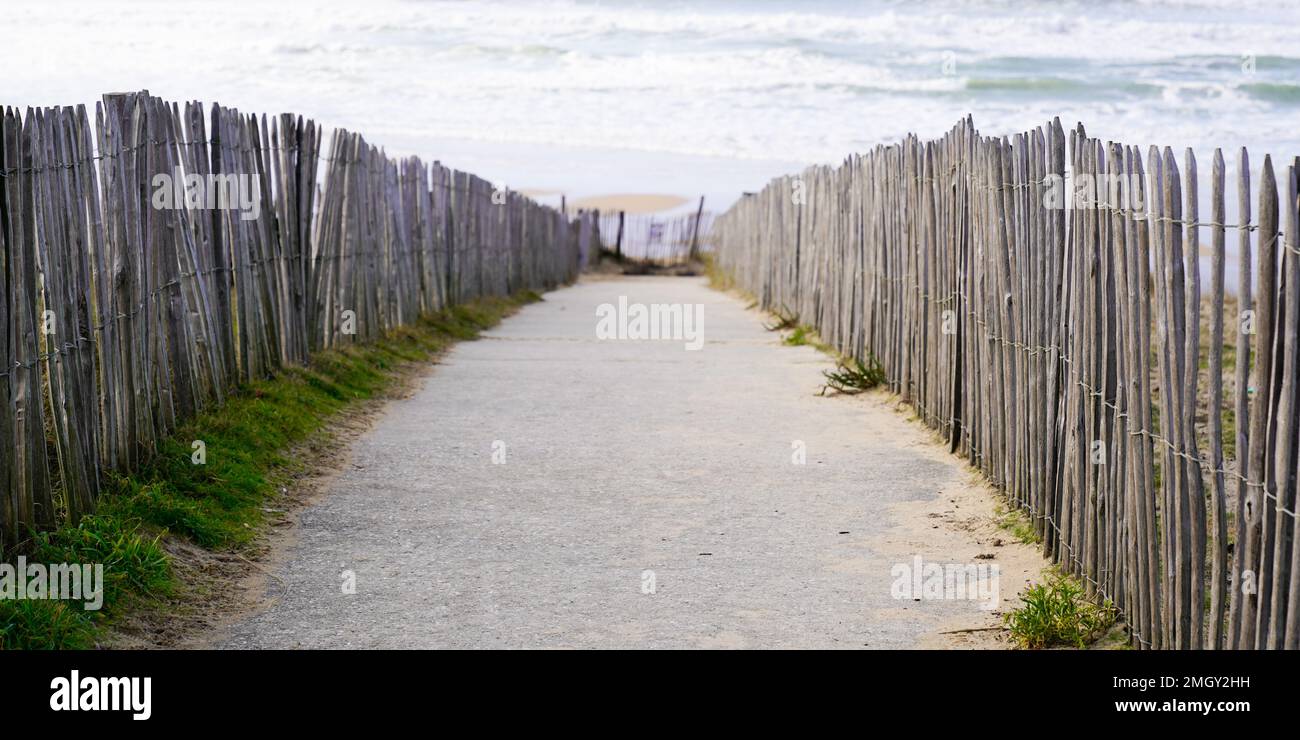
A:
0,0,1300,209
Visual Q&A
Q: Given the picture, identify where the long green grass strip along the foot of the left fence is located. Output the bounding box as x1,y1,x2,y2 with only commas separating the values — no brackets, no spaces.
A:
0,291,540,649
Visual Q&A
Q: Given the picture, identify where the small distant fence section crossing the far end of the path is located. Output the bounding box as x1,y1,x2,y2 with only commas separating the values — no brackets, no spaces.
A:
599,208,714,265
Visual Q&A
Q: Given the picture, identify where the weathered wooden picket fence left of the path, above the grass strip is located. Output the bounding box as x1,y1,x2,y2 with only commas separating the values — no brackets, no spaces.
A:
0,92,598,542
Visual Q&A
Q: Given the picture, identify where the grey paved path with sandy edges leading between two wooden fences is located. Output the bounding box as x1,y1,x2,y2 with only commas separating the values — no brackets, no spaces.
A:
213,276,1043,648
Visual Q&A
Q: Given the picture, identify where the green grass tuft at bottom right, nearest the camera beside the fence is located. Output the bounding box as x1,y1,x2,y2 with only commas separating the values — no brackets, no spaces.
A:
1004,575,1115,650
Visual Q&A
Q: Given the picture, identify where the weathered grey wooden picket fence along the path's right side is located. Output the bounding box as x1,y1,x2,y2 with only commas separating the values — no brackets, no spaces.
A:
712,113,1300,649
